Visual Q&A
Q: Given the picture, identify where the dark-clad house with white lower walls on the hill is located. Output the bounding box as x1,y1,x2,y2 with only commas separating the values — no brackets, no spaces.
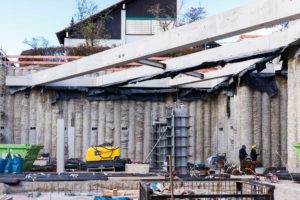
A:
56,0,180,47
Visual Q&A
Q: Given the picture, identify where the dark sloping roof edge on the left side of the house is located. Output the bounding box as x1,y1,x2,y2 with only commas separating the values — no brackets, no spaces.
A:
56,0,135,44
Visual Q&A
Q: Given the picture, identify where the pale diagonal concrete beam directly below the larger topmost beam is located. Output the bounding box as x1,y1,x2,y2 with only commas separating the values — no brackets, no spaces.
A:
95,22,300,87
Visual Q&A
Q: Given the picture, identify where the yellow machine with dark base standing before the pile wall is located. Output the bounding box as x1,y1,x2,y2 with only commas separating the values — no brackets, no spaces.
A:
86,144,125,170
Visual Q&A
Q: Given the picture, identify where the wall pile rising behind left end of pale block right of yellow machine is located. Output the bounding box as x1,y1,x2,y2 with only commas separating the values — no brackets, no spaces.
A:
128,100,136,161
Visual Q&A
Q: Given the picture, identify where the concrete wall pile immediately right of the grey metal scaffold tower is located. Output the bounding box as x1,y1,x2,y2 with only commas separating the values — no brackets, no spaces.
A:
188,101,197,163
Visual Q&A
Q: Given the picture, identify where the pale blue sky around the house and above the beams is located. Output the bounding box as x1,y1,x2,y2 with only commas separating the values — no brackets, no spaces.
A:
0,0,254,55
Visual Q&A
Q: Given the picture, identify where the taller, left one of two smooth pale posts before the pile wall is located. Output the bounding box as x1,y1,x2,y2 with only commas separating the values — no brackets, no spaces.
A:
56,119,65,173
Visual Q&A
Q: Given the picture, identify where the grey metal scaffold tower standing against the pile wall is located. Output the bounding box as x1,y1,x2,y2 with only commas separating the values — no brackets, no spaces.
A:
148,106,189,175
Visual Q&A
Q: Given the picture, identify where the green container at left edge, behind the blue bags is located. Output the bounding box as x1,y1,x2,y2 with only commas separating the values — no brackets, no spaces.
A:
0,144,44,171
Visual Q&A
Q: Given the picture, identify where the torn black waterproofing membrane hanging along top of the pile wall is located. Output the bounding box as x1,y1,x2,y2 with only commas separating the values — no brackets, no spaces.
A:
9,42,299,103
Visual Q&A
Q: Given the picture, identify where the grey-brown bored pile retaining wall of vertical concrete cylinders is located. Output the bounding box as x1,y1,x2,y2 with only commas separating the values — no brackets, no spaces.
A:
0,68,287,166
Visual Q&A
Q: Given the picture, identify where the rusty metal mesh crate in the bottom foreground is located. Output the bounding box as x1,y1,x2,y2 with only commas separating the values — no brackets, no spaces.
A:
140,179,275,200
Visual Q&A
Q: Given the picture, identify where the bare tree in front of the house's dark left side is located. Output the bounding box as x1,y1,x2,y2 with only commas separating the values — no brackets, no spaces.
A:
74,0,110,47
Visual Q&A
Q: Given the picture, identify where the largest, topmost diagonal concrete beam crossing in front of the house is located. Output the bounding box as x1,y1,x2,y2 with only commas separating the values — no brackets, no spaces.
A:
6,0,300,86
